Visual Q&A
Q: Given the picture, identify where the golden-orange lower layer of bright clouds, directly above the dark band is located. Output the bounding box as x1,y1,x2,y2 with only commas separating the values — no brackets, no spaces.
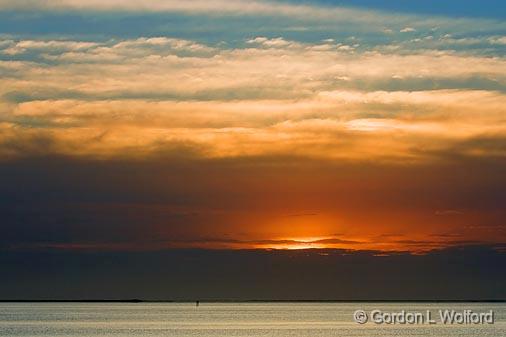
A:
1,92,505,161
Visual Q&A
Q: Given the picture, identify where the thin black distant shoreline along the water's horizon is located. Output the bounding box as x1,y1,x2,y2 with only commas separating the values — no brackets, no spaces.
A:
0,299,506,304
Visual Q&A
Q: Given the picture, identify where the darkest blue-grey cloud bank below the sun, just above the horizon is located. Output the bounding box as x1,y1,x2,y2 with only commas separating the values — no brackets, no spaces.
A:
0,246,506,300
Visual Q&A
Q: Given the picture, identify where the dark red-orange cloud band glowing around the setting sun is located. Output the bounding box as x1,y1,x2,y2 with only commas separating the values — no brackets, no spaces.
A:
0,152,506,250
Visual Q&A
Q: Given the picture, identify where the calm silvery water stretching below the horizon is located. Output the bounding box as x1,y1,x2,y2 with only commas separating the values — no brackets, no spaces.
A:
0,303,506,337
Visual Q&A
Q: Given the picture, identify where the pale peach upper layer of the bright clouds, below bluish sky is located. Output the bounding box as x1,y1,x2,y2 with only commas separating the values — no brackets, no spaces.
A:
0,37,506,98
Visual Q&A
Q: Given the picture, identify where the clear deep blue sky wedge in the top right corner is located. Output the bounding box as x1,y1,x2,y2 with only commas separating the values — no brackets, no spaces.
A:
287,0,506,19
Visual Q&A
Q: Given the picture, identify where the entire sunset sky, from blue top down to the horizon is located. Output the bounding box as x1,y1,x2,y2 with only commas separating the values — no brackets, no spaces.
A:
0,0,506,298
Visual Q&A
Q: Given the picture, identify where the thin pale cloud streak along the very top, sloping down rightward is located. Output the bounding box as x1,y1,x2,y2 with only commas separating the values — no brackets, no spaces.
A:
0,0,504,38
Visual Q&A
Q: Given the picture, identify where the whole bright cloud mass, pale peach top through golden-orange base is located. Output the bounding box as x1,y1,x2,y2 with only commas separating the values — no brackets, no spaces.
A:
0,33,506,161
